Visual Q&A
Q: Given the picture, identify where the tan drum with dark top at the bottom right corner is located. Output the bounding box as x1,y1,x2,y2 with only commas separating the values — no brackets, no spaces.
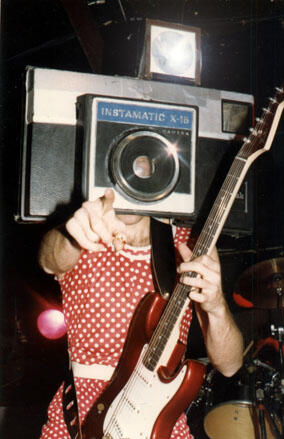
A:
204,370,280,439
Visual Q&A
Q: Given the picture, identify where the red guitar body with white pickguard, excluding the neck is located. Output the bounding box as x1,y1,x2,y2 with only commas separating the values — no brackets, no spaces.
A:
82,293,205,439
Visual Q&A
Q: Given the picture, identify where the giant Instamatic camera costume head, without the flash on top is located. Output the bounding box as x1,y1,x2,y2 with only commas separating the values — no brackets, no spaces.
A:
17,67,253,234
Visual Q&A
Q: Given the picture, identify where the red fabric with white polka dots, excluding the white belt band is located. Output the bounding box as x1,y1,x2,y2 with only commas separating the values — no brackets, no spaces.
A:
41,227,192,439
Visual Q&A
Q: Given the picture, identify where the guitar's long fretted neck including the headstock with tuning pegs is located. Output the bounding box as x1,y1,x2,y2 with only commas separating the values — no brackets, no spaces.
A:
143,88,284,370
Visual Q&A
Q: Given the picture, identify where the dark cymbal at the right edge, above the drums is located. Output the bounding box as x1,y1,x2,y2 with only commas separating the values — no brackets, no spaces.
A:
236,257,284,309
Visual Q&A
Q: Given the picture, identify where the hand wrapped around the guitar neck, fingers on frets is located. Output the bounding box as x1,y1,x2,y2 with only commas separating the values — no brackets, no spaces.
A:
177,244,225,315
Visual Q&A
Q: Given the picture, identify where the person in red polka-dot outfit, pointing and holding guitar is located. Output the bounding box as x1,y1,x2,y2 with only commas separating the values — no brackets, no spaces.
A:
39,189,243,439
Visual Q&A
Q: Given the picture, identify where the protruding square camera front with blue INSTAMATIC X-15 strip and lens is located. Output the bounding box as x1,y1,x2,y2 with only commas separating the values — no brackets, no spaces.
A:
77,94,198,217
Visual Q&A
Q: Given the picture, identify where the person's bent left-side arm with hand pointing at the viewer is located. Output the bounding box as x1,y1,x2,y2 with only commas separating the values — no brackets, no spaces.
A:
39,190,125,275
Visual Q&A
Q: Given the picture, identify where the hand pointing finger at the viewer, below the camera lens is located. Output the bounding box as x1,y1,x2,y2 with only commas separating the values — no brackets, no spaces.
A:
65,189,126,251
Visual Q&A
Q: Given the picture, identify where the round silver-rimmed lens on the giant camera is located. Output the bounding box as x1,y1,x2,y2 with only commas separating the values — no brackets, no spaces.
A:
110,130,179,202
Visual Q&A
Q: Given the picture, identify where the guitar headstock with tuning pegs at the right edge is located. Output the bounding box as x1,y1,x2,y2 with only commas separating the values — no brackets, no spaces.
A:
238,86,284,160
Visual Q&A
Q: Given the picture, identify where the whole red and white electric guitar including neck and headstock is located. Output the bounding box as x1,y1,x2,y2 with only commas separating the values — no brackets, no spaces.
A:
82,88,284,439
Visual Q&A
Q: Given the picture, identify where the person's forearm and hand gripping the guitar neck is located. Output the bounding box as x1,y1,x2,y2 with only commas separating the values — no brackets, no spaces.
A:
178,244,243,377
